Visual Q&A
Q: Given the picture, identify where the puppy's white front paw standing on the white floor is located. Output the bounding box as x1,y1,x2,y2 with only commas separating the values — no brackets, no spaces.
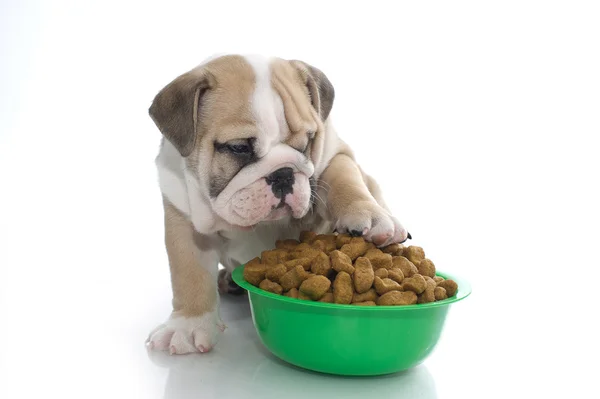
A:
146,311,225,355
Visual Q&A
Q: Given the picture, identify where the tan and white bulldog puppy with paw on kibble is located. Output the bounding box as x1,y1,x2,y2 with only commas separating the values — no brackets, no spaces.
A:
147,55,409,354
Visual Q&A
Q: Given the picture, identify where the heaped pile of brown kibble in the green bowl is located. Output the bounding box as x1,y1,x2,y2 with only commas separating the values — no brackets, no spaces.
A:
244,231,458,306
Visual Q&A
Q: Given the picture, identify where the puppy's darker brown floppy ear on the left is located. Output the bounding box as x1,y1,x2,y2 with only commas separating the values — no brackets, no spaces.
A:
149,69,214,157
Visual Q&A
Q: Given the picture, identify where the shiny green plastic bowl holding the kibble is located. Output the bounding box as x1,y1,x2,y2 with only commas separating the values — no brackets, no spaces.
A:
233,266,471,376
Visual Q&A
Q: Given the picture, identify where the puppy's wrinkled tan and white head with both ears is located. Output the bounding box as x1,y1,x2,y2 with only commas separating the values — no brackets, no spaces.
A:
150,55,334,231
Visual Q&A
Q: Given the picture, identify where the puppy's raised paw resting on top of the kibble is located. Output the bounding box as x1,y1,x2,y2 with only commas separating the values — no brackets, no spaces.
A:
335,201,411,247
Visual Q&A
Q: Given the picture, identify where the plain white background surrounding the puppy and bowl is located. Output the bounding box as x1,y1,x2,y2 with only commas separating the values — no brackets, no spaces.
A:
0,0,600,399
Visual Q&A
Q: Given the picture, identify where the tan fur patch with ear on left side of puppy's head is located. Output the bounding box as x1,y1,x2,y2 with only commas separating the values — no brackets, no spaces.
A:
150,55,257,196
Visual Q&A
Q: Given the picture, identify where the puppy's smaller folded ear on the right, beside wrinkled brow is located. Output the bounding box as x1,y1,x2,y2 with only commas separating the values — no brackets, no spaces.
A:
292,60,335,121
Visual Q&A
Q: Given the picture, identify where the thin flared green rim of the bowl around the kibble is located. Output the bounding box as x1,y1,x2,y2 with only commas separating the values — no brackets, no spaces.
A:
231,265,471,312
